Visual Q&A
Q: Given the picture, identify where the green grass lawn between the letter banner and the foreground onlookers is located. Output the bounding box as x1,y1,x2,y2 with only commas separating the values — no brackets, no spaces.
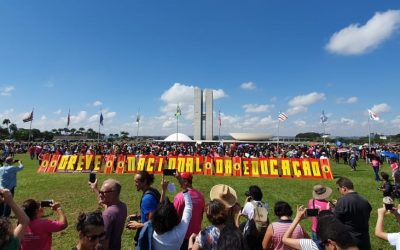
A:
8,155,399,249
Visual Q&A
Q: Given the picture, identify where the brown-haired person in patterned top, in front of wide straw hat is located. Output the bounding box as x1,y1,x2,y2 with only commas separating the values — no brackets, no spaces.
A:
188,199,227,250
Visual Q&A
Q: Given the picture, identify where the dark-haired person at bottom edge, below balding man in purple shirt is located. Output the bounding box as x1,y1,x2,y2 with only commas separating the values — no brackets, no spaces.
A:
71,211,106,250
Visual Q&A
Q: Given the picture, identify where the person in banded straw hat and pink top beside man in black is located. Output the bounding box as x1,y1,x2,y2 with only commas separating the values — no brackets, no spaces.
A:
308,185,332,249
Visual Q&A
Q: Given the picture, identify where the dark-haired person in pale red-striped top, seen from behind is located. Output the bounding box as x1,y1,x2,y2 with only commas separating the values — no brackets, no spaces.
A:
262,201,310,249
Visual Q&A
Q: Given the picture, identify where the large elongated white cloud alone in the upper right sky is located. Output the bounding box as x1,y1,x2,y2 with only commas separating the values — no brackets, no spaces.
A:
325,10,400,55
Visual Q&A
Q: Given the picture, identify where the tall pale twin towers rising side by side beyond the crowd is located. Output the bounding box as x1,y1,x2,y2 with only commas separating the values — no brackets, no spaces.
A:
193,88,213,140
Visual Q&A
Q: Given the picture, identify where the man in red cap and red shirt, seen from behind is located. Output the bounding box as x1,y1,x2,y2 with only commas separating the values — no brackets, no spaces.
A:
174,172,205,250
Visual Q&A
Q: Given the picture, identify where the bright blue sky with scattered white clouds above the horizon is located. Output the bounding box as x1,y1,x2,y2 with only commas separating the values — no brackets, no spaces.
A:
0,0,400,136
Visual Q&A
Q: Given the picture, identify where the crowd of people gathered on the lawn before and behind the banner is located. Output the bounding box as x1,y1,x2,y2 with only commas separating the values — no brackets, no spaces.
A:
0,144,400,250
